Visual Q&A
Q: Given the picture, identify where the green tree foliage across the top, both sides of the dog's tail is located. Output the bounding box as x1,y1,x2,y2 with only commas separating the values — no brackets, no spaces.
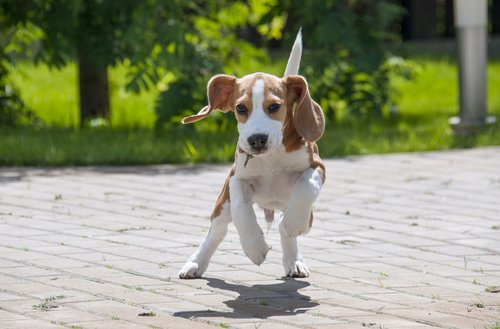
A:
0,0,402,130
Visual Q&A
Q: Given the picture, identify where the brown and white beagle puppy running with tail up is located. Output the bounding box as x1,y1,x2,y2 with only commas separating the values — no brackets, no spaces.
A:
179,32,325,279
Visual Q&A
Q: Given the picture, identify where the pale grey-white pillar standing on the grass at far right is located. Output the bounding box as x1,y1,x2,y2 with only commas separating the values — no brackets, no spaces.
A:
450,0,495,132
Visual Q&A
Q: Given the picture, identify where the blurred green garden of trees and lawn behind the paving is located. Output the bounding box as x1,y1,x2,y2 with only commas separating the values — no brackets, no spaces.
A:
0,0,500,166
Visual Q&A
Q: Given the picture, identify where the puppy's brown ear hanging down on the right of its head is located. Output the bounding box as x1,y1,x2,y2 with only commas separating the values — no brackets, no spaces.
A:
283,75,325,142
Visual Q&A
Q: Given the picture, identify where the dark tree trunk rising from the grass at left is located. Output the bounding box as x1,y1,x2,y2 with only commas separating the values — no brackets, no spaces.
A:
78,51,109,126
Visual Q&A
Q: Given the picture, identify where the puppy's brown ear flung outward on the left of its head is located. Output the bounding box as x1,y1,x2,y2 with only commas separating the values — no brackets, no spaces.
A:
182,74,237,124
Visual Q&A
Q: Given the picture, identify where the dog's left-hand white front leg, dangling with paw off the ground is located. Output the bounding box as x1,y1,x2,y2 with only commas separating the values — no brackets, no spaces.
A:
229,177,269,265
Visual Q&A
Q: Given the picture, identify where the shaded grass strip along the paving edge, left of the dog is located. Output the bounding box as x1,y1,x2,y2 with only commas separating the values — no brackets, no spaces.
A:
0,128,236,166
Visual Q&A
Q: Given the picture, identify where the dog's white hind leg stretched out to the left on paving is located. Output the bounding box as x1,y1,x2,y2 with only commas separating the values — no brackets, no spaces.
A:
179,201,231,279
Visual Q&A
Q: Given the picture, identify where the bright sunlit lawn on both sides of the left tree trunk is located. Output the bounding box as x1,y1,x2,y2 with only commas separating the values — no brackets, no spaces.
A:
12,63,157,129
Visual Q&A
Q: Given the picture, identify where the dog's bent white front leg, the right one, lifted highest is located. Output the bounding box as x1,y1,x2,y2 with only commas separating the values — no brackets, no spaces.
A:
283,168,323,238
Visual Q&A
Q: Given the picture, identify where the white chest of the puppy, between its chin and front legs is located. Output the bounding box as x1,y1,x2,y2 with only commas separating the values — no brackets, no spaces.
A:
235,147,310,210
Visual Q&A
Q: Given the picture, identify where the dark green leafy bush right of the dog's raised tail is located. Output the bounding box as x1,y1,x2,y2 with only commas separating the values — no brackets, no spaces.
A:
291,0,408,120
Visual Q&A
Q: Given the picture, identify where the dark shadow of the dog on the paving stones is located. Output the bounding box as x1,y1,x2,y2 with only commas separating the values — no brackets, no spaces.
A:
174,278,319,319
